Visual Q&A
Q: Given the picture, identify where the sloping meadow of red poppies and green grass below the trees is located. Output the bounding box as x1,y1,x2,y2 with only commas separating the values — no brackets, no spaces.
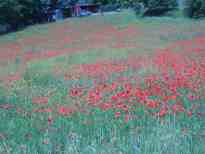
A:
0,11,205,154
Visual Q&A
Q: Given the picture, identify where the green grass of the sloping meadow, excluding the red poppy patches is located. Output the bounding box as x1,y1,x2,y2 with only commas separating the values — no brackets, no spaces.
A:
0,11,205,154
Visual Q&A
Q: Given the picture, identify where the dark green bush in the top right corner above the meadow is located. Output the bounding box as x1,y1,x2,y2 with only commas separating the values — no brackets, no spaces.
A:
184,0,205,18
